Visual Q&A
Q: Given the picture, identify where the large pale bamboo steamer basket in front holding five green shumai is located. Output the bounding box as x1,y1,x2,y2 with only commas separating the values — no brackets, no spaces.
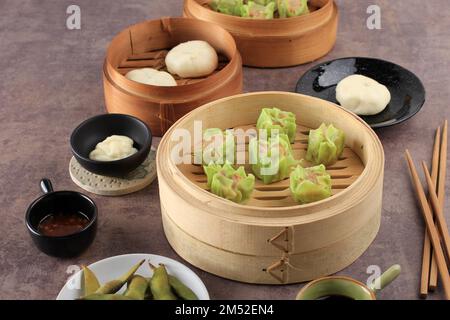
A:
156,92,384,284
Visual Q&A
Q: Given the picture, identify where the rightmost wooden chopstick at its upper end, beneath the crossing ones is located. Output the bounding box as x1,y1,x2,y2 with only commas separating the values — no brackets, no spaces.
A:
429,120,450,291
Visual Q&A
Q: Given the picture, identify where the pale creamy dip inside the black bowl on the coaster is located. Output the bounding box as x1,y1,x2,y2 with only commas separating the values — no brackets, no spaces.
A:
89,135,137,161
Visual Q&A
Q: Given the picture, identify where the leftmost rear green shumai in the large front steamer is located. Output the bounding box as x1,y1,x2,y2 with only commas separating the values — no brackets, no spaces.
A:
195,128,235,165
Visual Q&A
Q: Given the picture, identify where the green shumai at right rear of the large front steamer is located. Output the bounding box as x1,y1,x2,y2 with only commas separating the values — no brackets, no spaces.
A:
306,123,345,166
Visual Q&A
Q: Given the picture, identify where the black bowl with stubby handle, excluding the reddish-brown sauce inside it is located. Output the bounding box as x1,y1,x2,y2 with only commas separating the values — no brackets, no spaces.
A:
25,179,97,258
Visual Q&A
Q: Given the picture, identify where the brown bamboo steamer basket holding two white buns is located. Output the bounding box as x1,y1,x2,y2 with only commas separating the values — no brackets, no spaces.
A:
103,18,243,136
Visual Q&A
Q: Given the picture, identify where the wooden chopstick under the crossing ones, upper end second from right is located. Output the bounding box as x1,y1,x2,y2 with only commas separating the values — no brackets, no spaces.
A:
420,127,441,298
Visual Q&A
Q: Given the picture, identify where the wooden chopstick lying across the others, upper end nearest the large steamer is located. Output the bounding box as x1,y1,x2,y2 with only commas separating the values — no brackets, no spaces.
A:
405,150,450,300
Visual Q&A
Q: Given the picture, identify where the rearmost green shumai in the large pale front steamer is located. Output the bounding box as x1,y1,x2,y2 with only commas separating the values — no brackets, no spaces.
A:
256,108,297,143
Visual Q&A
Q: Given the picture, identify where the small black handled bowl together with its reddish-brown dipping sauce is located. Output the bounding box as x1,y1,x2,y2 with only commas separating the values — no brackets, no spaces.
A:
25,179,97,258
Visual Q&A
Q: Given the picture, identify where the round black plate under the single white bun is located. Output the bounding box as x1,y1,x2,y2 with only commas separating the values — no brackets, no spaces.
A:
295,57,425,128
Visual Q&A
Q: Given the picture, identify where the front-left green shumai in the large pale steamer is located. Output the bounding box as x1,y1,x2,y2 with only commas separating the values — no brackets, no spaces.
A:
203,163,255,203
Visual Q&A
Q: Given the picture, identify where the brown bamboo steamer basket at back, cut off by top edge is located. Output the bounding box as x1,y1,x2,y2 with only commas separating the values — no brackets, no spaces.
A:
184,0,338,67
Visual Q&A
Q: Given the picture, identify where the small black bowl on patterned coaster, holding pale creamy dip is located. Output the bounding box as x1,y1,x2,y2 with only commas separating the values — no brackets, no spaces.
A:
70,113,152,177
